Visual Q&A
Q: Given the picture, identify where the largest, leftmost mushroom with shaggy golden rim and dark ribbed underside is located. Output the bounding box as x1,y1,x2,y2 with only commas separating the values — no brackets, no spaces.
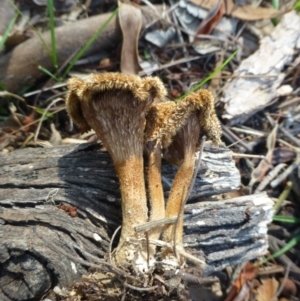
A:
66,73,166,263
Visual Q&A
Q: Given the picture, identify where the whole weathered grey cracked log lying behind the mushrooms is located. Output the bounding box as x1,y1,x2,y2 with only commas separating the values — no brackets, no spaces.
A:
0,143,272,301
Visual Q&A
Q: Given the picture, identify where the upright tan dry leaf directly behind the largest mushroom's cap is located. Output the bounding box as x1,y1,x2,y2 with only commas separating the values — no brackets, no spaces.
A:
119,1,142,74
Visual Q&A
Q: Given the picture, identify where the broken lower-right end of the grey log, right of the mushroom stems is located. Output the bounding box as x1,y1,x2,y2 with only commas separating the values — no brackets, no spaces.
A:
184,193,274,273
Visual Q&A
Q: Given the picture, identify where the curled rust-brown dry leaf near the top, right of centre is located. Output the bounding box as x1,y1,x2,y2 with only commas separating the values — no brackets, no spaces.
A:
196,0,225,35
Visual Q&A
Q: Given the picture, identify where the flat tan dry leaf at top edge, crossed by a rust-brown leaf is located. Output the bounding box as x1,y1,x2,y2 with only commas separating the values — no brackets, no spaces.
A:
189,0,280,21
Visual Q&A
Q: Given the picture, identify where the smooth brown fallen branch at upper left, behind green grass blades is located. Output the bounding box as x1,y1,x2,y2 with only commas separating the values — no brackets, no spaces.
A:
0,6,161,92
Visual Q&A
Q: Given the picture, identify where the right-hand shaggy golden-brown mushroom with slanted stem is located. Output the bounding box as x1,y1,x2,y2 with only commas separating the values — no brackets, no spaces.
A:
145,89,221,251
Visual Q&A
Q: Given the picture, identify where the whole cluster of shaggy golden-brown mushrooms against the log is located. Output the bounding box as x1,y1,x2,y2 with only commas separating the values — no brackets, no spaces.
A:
66,73,221,263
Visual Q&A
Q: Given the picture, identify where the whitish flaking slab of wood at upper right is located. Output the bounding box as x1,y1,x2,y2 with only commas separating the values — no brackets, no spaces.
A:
221,11,300,125
